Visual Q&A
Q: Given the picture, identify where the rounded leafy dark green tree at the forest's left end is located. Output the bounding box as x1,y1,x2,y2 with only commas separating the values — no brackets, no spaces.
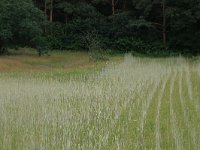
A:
0,0,43,46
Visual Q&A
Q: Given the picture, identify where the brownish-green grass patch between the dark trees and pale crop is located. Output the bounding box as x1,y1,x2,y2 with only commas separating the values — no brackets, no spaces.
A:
0,48,123,80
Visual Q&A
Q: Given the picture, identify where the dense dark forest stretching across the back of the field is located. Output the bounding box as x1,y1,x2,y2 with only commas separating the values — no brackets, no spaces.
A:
0,0,200,55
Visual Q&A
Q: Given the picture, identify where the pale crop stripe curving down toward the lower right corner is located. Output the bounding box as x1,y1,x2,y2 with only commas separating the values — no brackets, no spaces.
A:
179,68,197,149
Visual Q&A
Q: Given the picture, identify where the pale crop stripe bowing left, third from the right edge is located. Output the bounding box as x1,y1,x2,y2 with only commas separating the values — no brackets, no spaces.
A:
169,72,183,150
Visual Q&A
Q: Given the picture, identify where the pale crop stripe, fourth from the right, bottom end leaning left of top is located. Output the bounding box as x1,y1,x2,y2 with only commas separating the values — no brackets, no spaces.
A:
155,73,169,150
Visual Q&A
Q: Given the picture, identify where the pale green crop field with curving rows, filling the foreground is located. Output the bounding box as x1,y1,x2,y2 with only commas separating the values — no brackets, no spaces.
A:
0,53,200,150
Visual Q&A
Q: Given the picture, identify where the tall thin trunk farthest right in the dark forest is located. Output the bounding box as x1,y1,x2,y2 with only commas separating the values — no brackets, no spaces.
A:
162,0,167,48
